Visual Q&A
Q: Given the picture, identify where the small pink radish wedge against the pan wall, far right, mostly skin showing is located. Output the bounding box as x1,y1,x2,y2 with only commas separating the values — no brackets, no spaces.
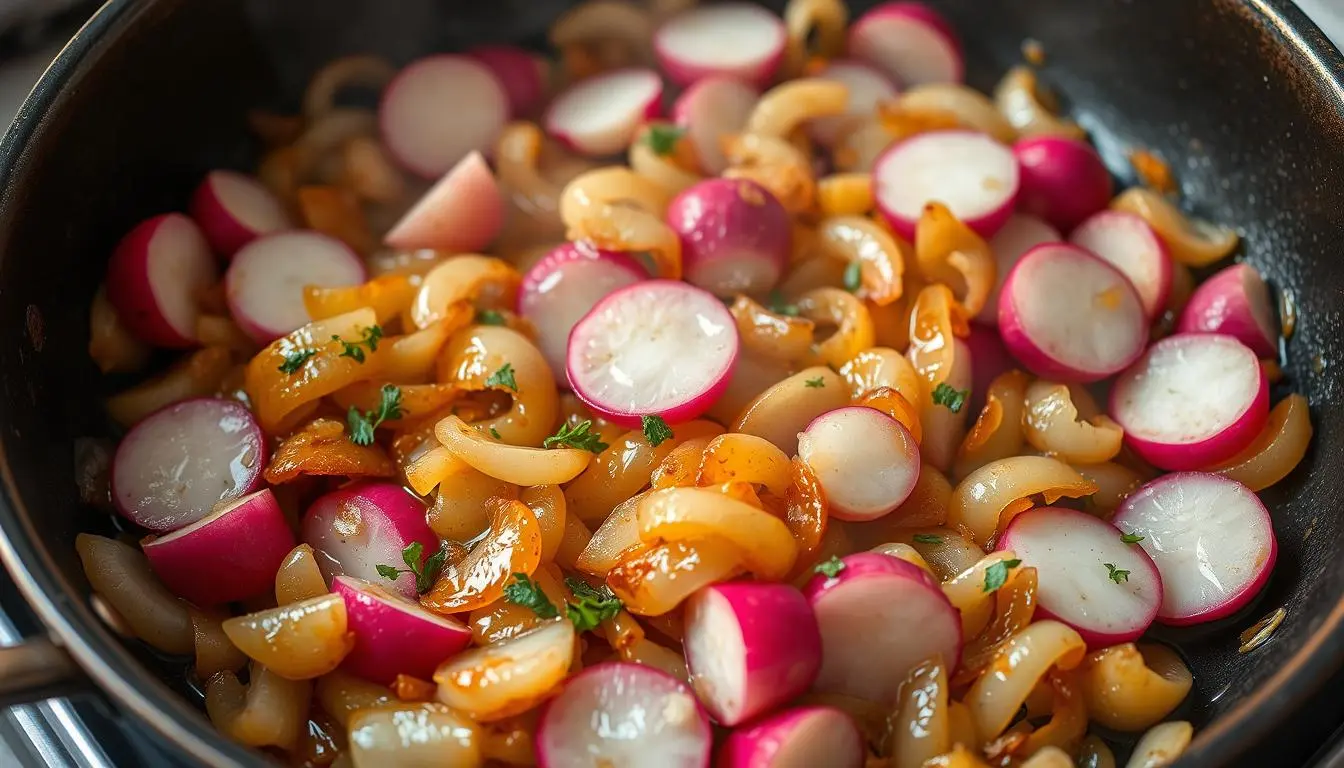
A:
1176,264,1278,358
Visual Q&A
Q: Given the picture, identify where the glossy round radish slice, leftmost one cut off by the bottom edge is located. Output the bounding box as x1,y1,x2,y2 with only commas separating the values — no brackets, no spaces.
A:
536,662,714,768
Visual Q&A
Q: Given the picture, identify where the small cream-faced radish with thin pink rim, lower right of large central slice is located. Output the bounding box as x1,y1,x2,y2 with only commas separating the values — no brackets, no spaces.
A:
798,405,919,522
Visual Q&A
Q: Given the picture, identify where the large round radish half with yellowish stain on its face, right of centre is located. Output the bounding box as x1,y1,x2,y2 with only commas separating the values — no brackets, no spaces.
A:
999,243,1148,382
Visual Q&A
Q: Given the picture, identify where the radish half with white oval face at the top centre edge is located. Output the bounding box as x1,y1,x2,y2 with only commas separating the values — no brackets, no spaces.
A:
653,3,788,87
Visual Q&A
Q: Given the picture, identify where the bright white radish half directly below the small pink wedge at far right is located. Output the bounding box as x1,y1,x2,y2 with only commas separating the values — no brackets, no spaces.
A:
1110,334,1269,469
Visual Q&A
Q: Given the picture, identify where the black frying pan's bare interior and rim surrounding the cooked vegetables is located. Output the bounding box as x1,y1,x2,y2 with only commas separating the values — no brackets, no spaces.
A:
0,0,1344,765
